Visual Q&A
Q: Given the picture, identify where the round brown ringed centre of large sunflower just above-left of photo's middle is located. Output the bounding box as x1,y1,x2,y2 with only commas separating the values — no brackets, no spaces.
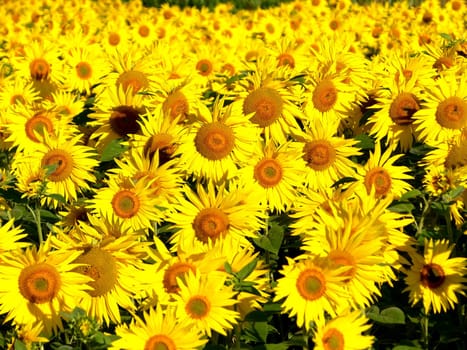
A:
195,122,235,160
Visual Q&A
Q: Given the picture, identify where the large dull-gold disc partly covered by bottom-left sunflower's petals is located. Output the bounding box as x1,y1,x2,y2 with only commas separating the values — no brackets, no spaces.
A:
75,247,118,297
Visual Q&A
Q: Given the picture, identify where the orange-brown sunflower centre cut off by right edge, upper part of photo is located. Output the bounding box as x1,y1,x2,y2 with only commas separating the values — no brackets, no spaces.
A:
436,96,467,129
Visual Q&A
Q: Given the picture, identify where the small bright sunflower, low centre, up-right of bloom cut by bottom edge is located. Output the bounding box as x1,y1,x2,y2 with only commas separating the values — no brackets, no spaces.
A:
174,271,239,337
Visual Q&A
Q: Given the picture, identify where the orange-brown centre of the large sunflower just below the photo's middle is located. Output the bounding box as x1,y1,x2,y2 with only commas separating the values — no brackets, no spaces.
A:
193,208,229,243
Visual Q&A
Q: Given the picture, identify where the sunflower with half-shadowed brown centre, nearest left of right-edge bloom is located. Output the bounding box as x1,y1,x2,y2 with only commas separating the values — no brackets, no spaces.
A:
367,76,421,152
